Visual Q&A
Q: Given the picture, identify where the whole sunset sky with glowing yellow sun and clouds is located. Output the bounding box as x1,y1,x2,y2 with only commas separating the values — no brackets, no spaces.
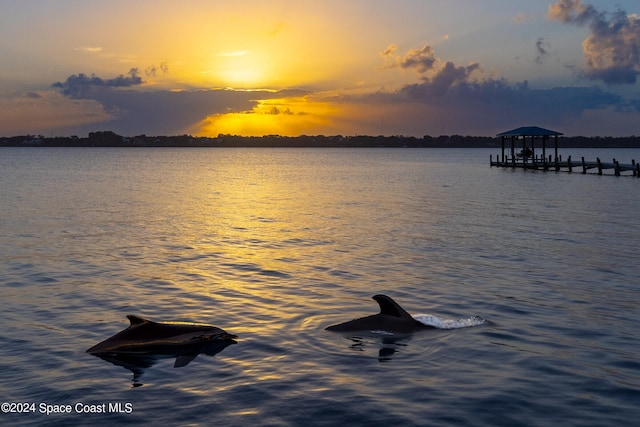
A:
0,0,640,137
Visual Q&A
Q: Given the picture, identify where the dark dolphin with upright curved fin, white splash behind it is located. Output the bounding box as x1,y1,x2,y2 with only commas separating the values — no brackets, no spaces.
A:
326,295,433,334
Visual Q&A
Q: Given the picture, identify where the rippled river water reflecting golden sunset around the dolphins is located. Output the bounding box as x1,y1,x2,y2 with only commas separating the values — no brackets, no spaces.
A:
0,148,640,426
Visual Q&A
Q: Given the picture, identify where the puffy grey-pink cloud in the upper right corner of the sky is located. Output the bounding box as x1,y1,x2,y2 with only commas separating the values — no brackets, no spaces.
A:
547,0,640,84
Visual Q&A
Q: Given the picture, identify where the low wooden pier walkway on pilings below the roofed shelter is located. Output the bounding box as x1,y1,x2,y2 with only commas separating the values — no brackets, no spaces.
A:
489,155,640,178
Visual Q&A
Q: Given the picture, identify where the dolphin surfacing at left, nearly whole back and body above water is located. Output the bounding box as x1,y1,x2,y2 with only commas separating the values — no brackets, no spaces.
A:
87,315,237,368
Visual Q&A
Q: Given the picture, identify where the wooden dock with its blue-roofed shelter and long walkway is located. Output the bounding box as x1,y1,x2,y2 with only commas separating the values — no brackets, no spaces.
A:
489,126,640,178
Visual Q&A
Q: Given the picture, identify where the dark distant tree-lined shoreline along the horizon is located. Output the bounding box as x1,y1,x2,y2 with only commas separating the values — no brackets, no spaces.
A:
0,131,640,148
